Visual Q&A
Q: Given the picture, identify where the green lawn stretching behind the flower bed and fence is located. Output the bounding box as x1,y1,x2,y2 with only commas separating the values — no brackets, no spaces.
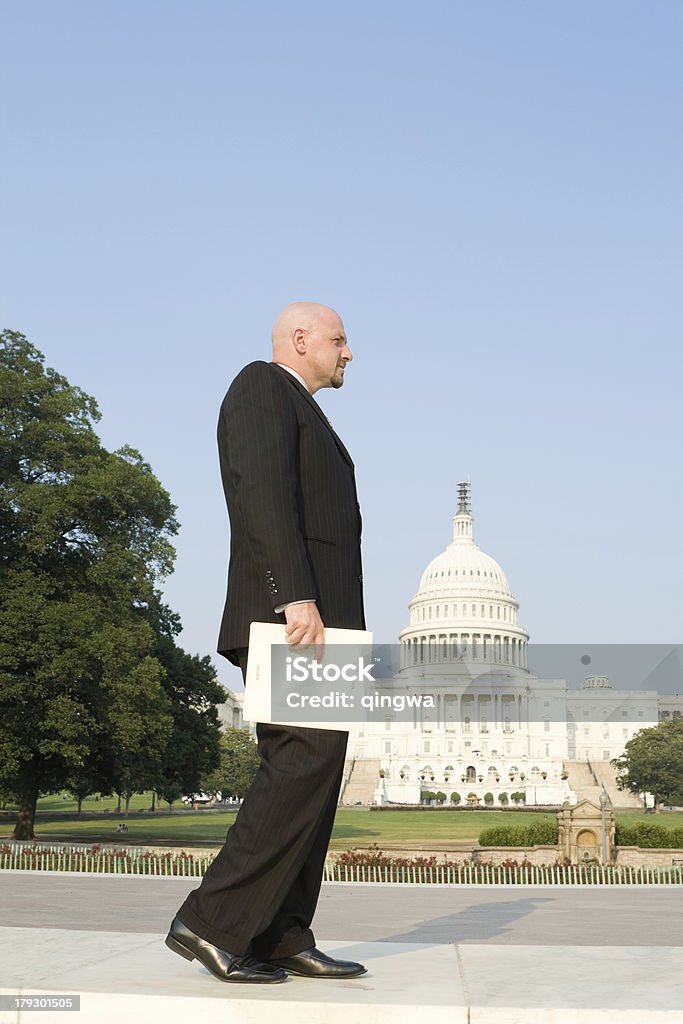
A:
0,798,683,850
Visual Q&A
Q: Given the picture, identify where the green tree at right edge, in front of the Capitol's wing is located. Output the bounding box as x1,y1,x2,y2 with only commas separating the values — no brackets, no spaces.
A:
611,719,683,811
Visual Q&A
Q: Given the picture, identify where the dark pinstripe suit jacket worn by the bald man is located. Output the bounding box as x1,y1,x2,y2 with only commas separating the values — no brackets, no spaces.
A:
218,361,365,664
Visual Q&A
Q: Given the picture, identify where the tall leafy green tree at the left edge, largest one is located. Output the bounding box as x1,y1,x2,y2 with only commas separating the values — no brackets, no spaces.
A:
0,331,177,839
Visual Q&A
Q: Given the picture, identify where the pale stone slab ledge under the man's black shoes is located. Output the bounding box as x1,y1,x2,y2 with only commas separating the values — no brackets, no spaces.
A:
0,928,683,1024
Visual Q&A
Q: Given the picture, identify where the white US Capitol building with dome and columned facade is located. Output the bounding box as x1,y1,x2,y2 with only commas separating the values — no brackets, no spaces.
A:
340,483,683,807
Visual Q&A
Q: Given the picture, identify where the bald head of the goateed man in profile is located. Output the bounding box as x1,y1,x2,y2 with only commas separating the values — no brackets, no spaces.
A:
272,302,353,394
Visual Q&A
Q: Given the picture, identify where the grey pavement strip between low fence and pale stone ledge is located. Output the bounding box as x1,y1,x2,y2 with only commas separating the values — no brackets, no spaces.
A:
0,871,683,942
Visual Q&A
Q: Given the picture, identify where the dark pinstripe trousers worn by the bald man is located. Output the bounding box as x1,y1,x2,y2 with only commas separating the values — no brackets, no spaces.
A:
178,649,348,959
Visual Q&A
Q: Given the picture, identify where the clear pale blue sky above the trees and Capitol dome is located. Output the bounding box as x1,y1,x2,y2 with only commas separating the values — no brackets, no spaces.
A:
0,0,683,684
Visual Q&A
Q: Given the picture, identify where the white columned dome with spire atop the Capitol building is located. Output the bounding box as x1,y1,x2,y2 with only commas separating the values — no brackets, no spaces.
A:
399,483,528,668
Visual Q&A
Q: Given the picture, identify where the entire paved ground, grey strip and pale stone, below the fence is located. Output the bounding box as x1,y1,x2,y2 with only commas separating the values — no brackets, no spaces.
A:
0,871,683,1024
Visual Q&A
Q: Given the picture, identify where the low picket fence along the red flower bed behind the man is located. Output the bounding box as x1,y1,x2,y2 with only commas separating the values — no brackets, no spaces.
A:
0,844,683,886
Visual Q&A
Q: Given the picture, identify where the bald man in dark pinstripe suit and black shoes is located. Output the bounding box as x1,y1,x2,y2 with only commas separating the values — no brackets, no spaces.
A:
166,302,366,983
